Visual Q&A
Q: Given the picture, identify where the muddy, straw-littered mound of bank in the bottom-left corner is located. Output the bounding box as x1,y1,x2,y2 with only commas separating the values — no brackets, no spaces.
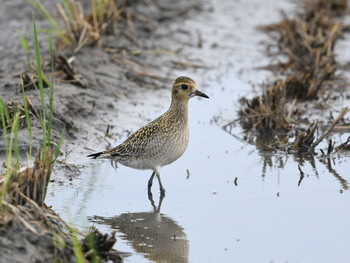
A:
0,208,76,262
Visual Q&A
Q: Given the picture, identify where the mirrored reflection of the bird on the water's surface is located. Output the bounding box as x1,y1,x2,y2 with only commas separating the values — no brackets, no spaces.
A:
91,195,189,263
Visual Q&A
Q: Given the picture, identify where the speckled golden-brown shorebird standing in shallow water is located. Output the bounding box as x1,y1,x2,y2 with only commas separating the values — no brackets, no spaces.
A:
88,76,209,195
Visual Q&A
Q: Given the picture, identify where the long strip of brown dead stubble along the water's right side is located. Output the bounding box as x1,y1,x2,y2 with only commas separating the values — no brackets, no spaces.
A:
224,0,348,152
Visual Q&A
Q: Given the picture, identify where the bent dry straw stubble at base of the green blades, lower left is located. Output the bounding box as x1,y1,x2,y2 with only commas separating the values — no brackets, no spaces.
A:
0,147,73,262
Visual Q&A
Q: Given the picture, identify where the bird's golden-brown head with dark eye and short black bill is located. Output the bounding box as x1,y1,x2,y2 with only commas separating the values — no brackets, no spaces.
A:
171,76,209,101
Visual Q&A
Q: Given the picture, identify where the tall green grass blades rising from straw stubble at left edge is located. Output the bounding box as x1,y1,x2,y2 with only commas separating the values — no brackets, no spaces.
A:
0,15,60,206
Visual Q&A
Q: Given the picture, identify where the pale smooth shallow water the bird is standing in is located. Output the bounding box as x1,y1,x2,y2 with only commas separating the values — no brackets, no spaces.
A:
47,74,350,262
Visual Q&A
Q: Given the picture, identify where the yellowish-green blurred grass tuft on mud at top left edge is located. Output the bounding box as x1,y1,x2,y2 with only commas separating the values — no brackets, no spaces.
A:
30,0,127,52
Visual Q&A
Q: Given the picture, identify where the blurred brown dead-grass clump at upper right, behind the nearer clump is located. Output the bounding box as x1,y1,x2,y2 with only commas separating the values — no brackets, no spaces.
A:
261,10,343,100
